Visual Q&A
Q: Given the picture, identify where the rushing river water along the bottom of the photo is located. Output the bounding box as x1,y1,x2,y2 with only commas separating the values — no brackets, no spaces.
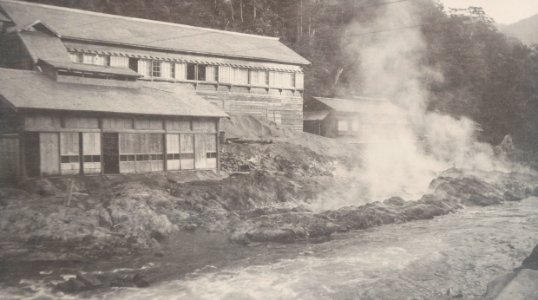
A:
0,198,538,300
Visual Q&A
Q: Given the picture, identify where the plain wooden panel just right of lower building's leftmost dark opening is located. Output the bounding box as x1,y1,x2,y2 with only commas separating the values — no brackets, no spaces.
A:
39,133,60,175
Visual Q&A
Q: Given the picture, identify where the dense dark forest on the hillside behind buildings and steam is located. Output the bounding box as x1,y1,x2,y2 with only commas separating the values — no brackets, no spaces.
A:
23,0,538,150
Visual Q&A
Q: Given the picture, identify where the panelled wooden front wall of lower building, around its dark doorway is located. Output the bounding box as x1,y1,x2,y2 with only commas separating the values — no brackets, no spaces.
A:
17,114,218,175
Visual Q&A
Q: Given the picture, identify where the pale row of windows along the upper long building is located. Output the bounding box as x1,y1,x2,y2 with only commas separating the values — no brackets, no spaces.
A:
70,52,304,89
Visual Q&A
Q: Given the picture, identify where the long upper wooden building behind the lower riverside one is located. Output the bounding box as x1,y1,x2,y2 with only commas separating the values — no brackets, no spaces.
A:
0,0,309,131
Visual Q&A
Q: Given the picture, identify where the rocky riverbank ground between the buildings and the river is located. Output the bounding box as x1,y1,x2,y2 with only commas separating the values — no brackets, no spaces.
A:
0,117,538,292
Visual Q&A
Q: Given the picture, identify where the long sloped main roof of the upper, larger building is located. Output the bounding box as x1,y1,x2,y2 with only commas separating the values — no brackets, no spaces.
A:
0,0,309,65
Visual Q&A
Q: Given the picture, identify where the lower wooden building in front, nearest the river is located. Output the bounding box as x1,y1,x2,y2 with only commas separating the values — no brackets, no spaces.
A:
0,60,227,180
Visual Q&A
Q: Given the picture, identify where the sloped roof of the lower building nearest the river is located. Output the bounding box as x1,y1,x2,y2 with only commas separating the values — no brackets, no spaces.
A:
0,68,227,117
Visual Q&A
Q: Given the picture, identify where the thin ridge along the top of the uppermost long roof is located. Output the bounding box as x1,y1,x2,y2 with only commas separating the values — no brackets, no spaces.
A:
0,0,280,41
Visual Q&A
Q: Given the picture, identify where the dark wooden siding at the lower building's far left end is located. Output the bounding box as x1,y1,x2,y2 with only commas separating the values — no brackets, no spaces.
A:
0,135,20,181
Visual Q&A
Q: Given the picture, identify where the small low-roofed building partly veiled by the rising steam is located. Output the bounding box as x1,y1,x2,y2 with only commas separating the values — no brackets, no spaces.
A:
303,97,392,143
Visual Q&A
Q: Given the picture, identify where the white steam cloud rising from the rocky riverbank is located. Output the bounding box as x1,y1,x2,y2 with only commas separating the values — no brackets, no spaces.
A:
344,1,510,204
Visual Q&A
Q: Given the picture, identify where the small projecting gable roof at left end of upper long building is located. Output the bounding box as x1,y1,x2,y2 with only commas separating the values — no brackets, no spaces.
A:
19,31,69,63
